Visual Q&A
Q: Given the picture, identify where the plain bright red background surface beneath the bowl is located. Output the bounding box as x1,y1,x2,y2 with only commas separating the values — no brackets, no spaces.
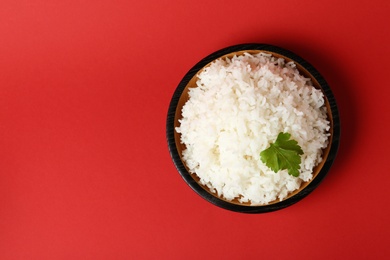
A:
0,0,390,260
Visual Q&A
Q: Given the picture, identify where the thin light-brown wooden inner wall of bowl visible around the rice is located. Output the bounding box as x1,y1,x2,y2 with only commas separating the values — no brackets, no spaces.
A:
174,50,334,206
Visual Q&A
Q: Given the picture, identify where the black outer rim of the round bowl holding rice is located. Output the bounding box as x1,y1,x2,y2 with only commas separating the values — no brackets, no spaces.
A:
166,43,341,213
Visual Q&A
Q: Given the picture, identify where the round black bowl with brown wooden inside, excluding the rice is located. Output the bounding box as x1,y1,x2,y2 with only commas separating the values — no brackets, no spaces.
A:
166,43,340,213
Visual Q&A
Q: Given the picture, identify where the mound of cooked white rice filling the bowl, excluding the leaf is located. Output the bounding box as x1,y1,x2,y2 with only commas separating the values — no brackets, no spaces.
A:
176,53,329,205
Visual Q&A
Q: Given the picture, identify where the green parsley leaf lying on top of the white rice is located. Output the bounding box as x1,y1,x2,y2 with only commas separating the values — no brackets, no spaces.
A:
260,132,303,177
